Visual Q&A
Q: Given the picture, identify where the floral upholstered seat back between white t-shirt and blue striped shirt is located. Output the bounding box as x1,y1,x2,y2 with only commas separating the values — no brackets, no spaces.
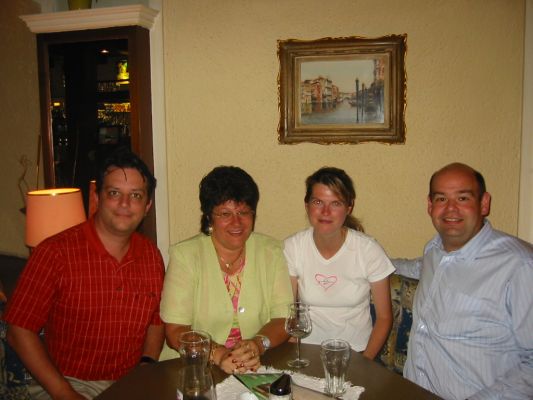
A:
370,274,418,374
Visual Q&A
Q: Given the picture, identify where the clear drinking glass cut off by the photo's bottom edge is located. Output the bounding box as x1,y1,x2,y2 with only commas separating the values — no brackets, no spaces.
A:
176,365,217,400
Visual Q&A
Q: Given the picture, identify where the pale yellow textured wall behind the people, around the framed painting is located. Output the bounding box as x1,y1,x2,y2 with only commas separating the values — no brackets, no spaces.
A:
159,0,524,257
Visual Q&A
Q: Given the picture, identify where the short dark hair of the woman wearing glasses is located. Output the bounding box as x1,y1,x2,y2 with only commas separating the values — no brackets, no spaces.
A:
199,166,259,235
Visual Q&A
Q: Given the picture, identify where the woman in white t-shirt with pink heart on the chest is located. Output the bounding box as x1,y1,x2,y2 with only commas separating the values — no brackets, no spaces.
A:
284,167,394,359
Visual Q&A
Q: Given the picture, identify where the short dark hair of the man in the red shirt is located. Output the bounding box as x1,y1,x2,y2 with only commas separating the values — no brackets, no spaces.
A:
96,147,157,200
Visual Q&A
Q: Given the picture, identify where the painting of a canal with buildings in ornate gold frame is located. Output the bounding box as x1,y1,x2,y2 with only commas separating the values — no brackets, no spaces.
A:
278,34,407,144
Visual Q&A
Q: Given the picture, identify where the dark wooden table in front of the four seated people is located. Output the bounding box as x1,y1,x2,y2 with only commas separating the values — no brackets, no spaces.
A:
96,343,439,400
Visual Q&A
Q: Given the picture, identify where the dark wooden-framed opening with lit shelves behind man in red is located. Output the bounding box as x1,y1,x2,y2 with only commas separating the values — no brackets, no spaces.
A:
37,26,157,242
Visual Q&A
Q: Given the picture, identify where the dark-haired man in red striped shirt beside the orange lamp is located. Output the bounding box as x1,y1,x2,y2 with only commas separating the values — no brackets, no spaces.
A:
4,150,164,399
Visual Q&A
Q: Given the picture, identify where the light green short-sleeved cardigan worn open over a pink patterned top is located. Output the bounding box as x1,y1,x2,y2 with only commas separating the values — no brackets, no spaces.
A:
161,233,293,360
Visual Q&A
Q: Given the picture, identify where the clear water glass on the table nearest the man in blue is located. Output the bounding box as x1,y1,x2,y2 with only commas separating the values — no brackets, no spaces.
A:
320,339,351,397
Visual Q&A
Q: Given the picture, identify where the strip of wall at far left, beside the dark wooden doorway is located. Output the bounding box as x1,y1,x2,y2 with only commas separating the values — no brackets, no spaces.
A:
0,0,40,256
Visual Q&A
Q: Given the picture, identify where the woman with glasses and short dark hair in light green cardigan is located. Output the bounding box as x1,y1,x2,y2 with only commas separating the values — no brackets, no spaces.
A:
161,166,292,373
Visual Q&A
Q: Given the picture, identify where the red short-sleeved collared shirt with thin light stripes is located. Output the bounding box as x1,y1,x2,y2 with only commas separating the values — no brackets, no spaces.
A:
4,220,164,380
